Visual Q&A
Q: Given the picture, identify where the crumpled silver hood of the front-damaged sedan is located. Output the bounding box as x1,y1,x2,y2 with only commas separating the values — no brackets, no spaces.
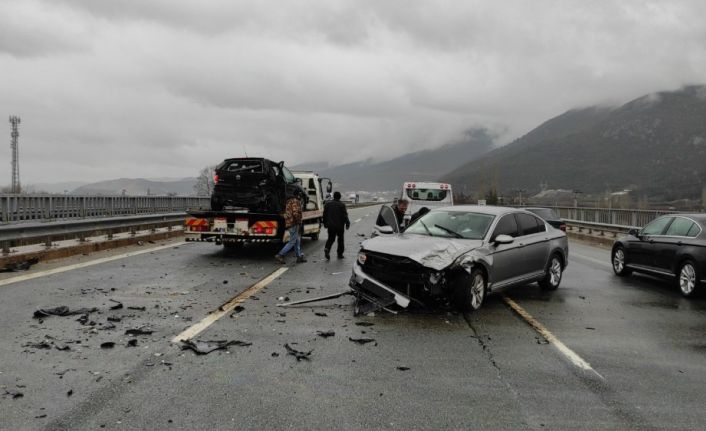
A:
362,234,483,271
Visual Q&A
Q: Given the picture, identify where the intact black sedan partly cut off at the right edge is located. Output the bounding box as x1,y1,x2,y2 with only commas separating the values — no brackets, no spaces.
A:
611,214,706,297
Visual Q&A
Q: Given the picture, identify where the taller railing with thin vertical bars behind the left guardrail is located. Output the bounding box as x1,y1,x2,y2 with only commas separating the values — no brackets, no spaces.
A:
0,194,210,223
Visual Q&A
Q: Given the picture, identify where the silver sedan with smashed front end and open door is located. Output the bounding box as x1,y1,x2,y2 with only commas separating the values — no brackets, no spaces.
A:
350,205,569,313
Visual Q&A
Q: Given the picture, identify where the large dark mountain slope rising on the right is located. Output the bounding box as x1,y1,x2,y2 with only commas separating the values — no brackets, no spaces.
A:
441,86,706,200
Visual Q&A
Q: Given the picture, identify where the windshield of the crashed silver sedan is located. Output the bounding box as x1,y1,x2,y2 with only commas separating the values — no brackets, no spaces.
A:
405,211,495,239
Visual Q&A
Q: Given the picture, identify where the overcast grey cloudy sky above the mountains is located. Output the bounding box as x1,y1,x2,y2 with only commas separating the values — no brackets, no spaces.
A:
0,0,706,184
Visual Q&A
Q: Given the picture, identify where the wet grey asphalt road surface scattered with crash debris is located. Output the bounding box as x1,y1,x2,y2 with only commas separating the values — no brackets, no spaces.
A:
0,208,706,430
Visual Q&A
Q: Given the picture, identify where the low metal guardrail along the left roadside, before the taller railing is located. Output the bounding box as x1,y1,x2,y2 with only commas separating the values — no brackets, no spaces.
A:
0,212,185,254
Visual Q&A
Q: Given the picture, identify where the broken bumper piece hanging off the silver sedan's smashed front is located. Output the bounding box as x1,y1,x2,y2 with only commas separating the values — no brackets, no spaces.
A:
349,263,411,315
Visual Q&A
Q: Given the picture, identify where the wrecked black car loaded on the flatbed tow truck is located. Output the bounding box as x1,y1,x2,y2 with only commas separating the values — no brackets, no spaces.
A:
211,158,306,213
